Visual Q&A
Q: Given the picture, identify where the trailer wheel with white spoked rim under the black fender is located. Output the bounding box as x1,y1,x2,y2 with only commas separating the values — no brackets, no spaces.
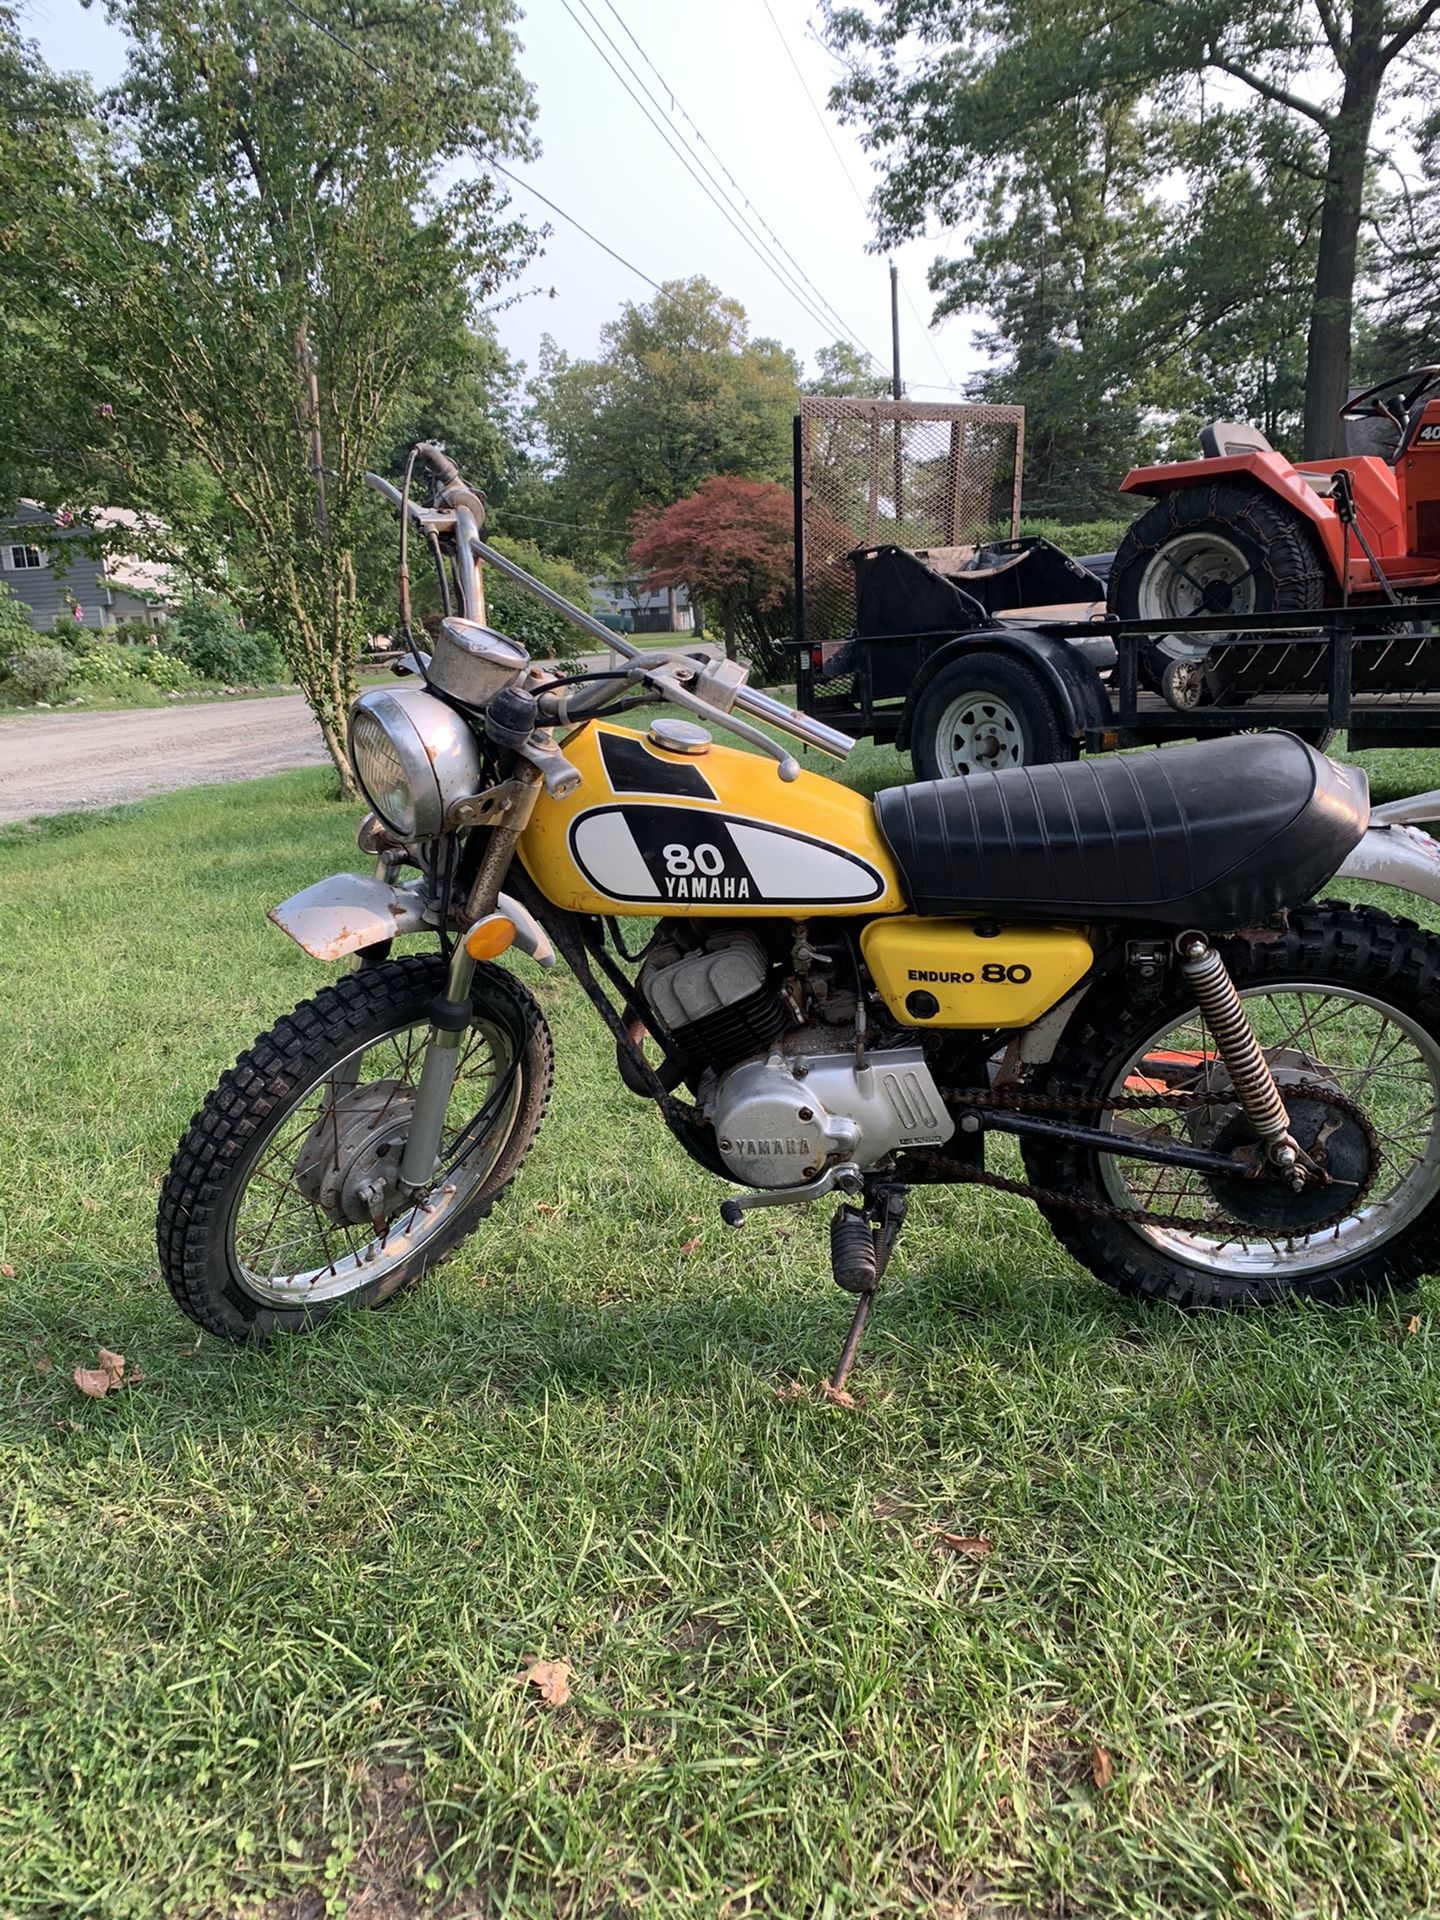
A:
910,651,1079,780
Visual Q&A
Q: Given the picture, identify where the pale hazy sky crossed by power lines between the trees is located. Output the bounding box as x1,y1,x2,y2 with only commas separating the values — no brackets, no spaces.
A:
23,0,981,399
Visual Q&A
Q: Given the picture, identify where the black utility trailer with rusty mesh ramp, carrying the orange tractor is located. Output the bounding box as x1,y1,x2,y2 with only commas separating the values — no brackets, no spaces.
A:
795,397,1440,780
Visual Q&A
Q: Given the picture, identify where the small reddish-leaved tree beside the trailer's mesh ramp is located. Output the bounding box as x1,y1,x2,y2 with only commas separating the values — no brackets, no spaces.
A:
630,474,795,685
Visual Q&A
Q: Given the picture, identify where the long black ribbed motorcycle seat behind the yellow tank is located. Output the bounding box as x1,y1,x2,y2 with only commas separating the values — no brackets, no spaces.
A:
876,733,1369,933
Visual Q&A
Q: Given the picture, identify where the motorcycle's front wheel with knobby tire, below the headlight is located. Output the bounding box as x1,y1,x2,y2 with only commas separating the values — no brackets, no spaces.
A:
157,954,553,1340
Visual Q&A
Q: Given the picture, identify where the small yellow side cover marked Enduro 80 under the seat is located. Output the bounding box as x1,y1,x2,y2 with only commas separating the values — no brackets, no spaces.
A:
860,914,1094,1027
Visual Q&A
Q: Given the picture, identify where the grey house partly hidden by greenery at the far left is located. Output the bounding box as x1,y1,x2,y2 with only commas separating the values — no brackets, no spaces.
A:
0,499,175,632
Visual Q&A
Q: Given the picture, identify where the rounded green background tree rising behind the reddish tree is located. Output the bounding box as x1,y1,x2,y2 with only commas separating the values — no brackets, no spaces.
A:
534,278,801,559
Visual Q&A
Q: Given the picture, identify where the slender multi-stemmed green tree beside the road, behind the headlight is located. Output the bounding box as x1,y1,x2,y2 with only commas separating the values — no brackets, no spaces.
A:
9,0,530,787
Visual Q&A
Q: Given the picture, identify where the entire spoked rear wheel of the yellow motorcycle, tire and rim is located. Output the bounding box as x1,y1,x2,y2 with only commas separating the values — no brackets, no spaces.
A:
1025,902,1440,1308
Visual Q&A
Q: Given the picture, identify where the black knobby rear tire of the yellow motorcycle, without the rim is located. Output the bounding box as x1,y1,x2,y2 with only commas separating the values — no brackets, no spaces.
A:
1023,900,1440,1308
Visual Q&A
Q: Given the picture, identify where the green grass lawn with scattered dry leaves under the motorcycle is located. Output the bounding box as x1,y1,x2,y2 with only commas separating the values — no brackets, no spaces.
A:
0,751,1440,1920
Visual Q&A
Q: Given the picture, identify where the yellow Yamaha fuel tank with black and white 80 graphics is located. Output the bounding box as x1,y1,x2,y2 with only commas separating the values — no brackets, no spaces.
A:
518,722,906,920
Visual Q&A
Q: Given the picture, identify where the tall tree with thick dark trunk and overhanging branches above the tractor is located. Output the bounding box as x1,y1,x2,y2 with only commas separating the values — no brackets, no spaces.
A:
828,0,1440,457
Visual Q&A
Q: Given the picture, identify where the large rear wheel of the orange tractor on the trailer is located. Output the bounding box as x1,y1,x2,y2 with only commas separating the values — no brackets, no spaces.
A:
1106,480,1329,705
